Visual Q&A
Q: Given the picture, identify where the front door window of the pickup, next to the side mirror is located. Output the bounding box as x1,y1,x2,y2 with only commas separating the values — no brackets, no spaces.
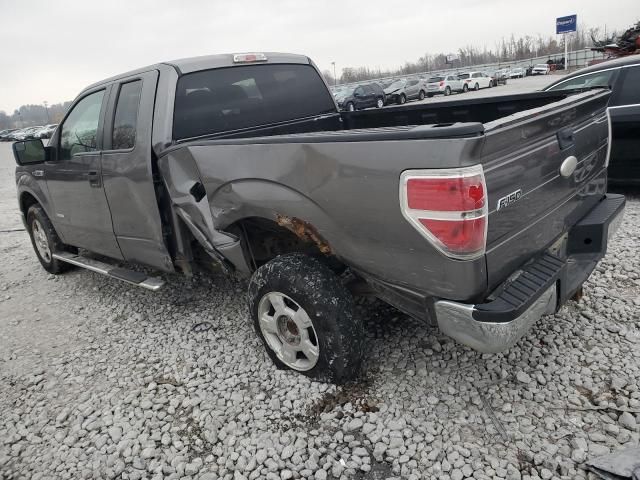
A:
58,90,104,160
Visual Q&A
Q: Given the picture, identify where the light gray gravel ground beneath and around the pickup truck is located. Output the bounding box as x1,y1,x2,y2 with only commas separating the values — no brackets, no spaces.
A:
0,136,640,480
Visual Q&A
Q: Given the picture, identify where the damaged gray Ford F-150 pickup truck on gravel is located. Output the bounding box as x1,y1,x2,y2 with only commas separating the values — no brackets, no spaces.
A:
13,53,625,382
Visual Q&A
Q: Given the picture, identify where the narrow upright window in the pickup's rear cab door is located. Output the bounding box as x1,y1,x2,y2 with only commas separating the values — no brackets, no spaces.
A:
111,80,142,150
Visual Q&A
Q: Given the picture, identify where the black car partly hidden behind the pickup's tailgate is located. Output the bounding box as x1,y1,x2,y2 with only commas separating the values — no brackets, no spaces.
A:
545,55,640,185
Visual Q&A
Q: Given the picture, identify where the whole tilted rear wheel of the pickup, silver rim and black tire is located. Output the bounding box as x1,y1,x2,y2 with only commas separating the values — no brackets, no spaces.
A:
249,253,364,384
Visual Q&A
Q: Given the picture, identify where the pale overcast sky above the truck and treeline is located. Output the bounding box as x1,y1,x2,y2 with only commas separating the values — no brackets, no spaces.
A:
0,0,640,113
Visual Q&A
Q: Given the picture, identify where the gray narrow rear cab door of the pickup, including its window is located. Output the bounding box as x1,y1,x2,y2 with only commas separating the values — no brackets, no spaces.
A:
102,70,172,270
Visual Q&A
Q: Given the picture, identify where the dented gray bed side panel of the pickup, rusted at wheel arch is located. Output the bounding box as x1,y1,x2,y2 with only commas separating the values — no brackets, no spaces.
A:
160,137,486,299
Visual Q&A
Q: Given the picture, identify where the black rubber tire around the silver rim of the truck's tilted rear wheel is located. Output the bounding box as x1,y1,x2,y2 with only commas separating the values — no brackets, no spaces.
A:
249,253,364,384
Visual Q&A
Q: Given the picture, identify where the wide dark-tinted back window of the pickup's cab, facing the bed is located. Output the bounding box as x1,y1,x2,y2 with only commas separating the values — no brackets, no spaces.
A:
173,64,336,140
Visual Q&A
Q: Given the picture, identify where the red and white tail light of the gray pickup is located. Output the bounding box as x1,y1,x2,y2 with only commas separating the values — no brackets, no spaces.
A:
400,165,488,260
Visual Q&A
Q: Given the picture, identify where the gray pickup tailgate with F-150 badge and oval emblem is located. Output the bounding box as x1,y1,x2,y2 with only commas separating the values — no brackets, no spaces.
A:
482,90,609,289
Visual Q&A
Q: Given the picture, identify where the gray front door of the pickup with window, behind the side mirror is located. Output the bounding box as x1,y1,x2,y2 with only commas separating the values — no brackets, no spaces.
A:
44,88,122,259
